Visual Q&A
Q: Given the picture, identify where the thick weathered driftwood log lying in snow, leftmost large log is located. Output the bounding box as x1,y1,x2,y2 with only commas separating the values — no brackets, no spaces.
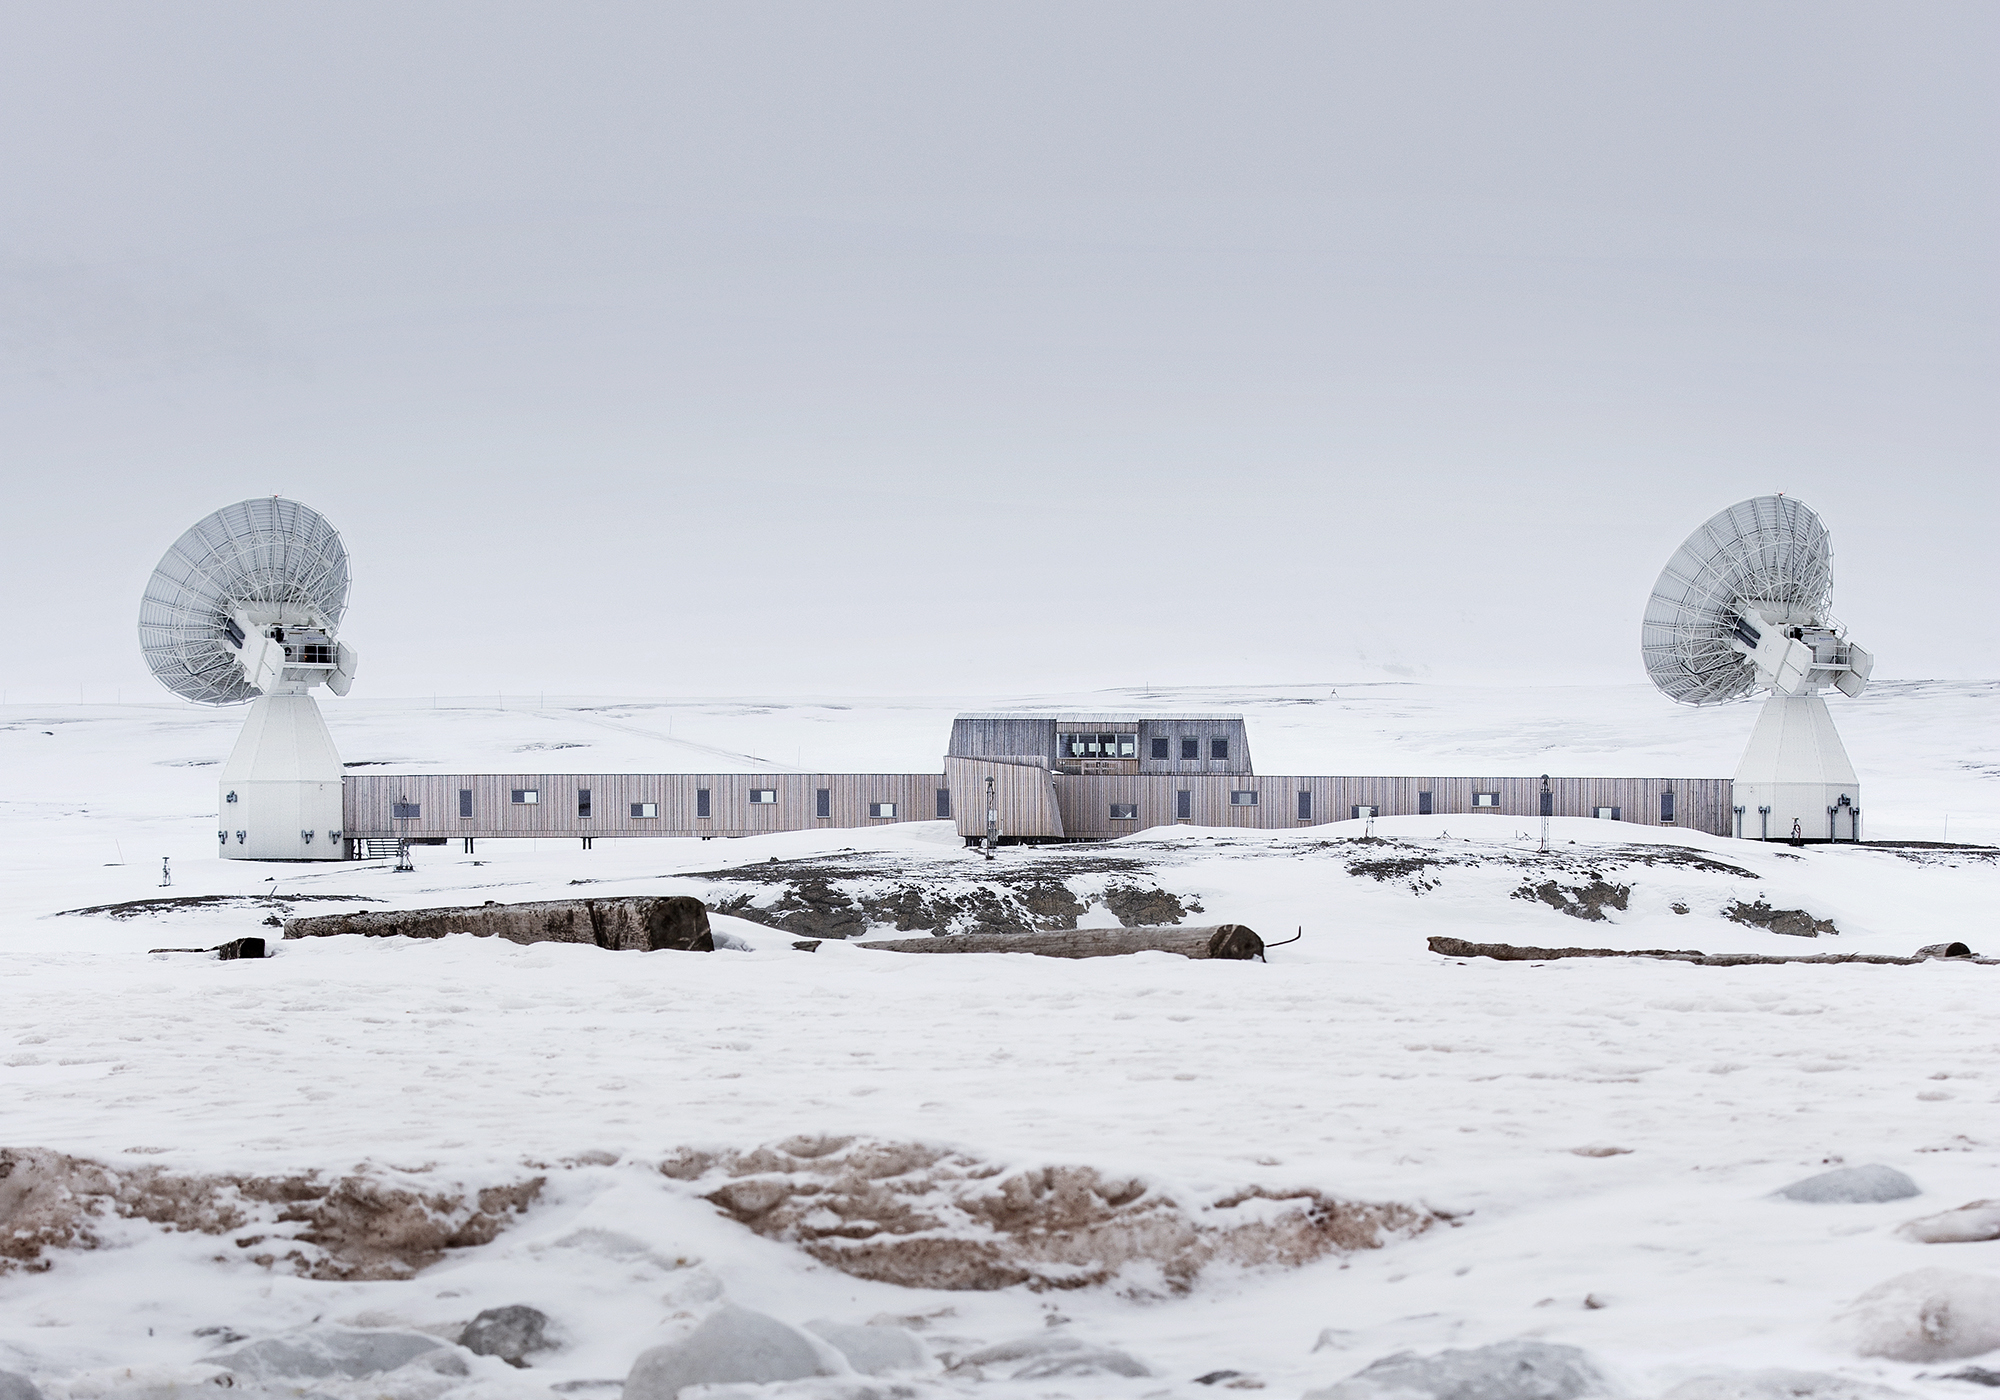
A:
284,894,716,952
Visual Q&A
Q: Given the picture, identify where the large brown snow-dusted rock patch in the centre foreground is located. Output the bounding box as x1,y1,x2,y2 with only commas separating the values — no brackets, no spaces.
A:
660,1138,1438,1292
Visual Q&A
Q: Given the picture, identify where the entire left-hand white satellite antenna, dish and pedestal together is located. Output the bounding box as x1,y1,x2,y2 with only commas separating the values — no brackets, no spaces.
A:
138,496,356,860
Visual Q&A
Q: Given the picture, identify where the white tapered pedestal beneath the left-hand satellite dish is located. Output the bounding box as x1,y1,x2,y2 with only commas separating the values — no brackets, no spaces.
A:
216,692,346,860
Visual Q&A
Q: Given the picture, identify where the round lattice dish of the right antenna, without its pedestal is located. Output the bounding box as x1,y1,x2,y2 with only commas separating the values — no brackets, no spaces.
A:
1640,496,1834,704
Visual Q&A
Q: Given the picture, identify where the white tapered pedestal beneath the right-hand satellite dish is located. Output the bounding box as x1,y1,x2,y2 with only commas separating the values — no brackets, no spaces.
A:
1734,694,1862,842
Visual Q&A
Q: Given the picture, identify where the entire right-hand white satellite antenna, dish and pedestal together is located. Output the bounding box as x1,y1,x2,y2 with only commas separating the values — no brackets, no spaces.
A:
1640,496,1874,840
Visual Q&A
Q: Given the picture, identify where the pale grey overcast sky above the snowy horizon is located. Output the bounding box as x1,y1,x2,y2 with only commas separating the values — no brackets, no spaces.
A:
0,0,2000,704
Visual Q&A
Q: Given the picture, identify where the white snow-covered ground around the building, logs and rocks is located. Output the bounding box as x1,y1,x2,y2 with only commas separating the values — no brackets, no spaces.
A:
0,682,2000,1400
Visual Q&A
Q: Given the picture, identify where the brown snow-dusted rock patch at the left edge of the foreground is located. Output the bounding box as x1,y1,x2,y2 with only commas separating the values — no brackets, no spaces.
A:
0,1148,544,1280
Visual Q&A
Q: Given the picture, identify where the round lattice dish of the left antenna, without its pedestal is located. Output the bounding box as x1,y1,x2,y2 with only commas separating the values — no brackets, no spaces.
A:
138,496,348,704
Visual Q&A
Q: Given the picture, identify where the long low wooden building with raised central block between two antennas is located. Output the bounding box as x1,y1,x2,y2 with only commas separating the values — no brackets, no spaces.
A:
342,712,1742,854
